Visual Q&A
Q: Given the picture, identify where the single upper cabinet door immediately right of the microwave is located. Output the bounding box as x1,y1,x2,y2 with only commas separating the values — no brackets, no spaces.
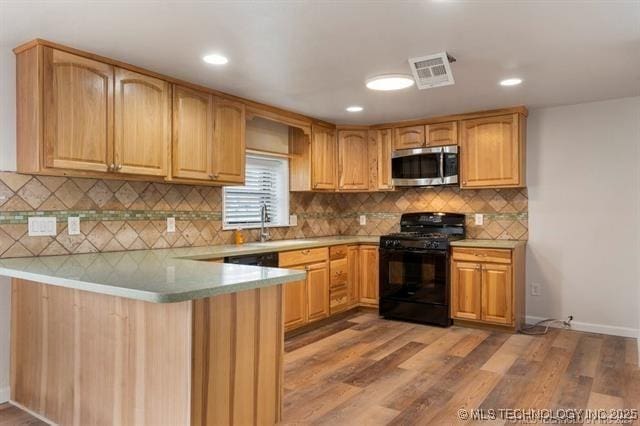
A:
460,114,524,188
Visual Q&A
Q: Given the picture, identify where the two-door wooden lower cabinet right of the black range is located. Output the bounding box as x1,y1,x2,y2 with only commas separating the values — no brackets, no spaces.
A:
451,243,525,330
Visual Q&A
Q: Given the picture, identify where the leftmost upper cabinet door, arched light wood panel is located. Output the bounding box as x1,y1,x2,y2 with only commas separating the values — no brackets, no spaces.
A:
42,47,113,172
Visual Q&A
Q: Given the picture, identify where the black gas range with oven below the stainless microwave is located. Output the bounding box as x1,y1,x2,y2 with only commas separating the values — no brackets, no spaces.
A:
380,213,465,326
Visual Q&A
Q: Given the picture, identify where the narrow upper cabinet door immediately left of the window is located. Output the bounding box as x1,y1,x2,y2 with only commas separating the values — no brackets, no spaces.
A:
212,98,245,183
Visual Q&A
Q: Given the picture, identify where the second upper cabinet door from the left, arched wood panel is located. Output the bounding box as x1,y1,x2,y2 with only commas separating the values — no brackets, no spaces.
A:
114,68,171,176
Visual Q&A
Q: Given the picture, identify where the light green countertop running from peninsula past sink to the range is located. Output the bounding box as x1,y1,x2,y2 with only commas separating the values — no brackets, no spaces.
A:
0,236,379,303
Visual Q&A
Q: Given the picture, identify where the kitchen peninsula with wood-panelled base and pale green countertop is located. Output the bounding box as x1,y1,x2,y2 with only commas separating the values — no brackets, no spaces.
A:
0,245,312,425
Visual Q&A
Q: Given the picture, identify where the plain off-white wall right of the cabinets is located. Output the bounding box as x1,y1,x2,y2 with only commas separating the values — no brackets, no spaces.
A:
527,97,640,336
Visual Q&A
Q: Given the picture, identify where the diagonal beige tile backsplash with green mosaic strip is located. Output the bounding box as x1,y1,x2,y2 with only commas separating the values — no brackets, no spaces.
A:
0,172,528,257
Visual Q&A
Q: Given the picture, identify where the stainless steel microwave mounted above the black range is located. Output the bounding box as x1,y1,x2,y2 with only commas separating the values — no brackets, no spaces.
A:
391,146,458,186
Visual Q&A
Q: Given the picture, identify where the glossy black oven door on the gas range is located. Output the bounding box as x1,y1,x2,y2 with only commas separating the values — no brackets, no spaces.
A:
380,249,449,306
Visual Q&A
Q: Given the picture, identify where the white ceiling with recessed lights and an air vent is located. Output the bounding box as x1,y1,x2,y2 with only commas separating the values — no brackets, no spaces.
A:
0,0,640,124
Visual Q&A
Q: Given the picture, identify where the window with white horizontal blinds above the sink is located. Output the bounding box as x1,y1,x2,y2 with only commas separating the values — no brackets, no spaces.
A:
223,155,289,229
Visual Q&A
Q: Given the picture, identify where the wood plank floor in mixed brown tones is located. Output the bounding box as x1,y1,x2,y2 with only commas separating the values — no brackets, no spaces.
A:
0,312,640,426
